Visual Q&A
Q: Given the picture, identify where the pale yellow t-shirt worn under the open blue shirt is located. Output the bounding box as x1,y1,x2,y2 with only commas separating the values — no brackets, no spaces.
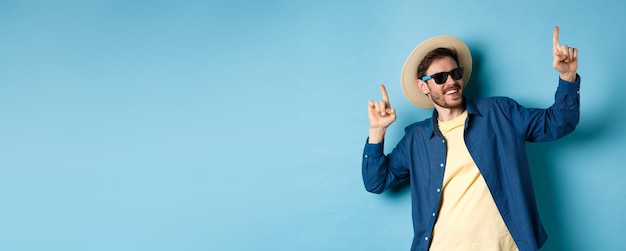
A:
430,111,518,251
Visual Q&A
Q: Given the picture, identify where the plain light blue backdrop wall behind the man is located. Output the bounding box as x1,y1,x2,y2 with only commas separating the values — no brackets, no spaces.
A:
0,0,626,250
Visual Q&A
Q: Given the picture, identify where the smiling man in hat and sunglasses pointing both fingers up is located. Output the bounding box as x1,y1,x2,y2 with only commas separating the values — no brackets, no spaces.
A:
362,27,580,250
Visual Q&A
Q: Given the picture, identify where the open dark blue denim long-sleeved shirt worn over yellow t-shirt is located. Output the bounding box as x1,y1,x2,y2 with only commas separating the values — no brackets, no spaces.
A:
362,76,580,250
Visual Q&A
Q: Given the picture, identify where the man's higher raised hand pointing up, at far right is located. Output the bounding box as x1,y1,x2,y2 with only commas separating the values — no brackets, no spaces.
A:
552,26,578,82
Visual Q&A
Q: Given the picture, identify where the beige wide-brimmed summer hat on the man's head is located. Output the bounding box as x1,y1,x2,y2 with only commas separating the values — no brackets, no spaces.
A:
400,36,472,108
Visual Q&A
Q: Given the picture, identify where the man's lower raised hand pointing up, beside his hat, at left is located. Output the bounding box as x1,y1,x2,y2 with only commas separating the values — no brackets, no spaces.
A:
368,84,396,144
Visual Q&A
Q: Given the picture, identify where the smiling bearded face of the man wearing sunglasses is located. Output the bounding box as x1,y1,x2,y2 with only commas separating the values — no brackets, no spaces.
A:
418,57,463,109
